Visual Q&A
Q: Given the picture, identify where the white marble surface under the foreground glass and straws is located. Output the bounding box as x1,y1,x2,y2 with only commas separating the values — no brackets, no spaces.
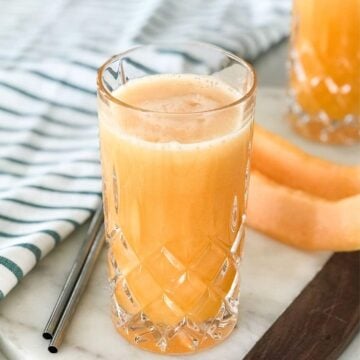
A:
0,88,360,360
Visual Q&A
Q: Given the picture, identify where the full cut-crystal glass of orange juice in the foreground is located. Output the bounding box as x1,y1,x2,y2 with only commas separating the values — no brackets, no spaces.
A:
98,43,255,354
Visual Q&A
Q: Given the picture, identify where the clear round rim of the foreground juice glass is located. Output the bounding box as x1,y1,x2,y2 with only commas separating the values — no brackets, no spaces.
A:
96,41,257,116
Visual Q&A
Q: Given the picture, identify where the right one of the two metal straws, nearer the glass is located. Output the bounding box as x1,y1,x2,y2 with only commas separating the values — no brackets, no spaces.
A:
48,223,105,353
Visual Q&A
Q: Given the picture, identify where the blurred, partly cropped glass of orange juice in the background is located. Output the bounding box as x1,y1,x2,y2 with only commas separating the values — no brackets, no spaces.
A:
290,0,360,143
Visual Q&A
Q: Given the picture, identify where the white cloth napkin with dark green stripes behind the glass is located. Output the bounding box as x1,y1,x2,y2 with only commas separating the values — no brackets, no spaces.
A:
0,0,289,299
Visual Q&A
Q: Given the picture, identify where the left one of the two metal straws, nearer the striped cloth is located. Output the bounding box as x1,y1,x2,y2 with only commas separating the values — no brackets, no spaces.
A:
42,203,104,340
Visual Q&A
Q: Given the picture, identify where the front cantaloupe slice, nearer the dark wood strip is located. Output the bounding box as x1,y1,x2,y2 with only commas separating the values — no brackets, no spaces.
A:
247,171,360,251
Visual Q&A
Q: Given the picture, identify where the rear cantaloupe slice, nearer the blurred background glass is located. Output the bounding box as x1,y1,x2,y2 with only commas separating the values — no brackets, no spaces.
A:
252,125,360,200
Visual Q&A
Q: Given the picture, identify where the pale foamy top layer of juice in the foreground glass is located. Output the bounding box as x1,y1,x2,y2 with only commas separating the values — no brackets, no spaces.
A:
106,74,248,145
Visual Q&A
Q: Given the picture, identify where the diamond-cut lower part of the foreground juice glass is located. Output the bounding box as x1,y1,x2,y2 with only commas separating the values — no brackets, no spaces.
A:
108,225,240,352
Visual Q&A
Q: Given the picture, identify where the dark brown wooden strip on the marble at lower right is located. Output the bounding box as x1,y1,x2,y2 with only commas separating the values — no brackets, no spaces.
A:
244,251,360,360
